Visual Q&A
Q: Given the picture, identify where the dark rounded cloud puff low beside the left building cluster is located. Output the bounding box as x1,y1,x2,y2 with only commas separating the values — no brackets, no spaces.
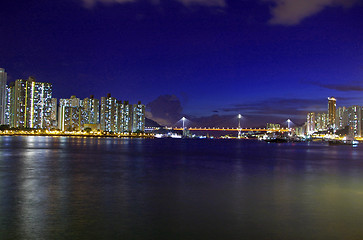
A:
146,95,183,126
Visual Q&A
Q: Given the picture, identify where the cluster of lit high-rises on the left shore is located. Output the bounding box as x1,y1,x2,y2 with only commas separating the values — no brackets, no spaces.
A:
0,73,145,134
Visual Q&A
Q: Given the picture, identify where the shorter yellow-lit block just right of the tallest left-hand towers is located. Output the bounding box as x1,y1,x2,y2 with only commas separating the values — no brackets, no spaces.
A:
58,96,86,131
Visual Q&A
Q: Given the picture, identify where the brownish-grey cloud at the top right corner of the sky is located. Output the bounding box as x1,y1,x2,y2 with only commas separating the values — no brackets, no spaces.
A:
267,0,359,25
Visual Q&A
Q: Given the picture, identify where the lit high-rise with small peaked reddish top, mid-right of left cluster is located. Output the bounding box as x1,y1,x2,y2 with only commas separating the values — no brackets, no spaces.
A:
100,93,119,132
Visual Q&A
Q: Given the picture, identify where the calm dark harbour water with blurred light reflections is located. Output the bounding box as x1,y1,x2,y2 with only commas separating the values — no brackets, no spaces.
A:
0,137,363,240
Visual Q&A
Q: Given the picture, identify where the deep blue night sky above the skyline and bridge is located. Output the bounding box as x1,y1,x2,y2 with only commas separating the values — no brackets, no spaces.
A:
0,0,363,126
